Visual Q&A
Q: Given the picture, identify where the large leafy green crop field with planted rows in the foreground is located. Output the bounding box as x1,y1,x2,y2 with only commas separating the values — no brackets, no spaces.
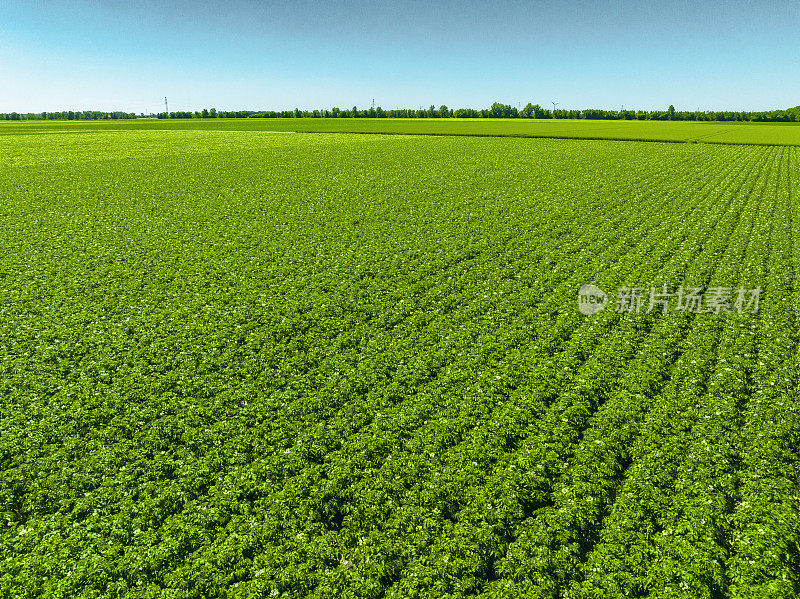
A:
0,132,800,599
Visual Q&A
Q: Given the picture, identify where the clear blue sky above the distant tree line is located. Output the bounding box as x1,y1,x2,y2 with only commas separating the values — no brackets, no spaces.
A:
0,0,800,113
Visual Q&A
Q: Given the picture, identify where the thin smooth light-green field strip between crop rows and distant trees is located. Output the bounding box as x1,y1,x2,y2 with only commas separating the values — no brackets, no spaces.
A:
0,118,800,145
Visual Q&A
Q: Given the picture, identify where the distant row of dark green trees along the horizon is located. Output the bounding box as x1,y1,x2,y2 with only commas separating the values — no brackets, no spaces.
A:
0,102,800,123
